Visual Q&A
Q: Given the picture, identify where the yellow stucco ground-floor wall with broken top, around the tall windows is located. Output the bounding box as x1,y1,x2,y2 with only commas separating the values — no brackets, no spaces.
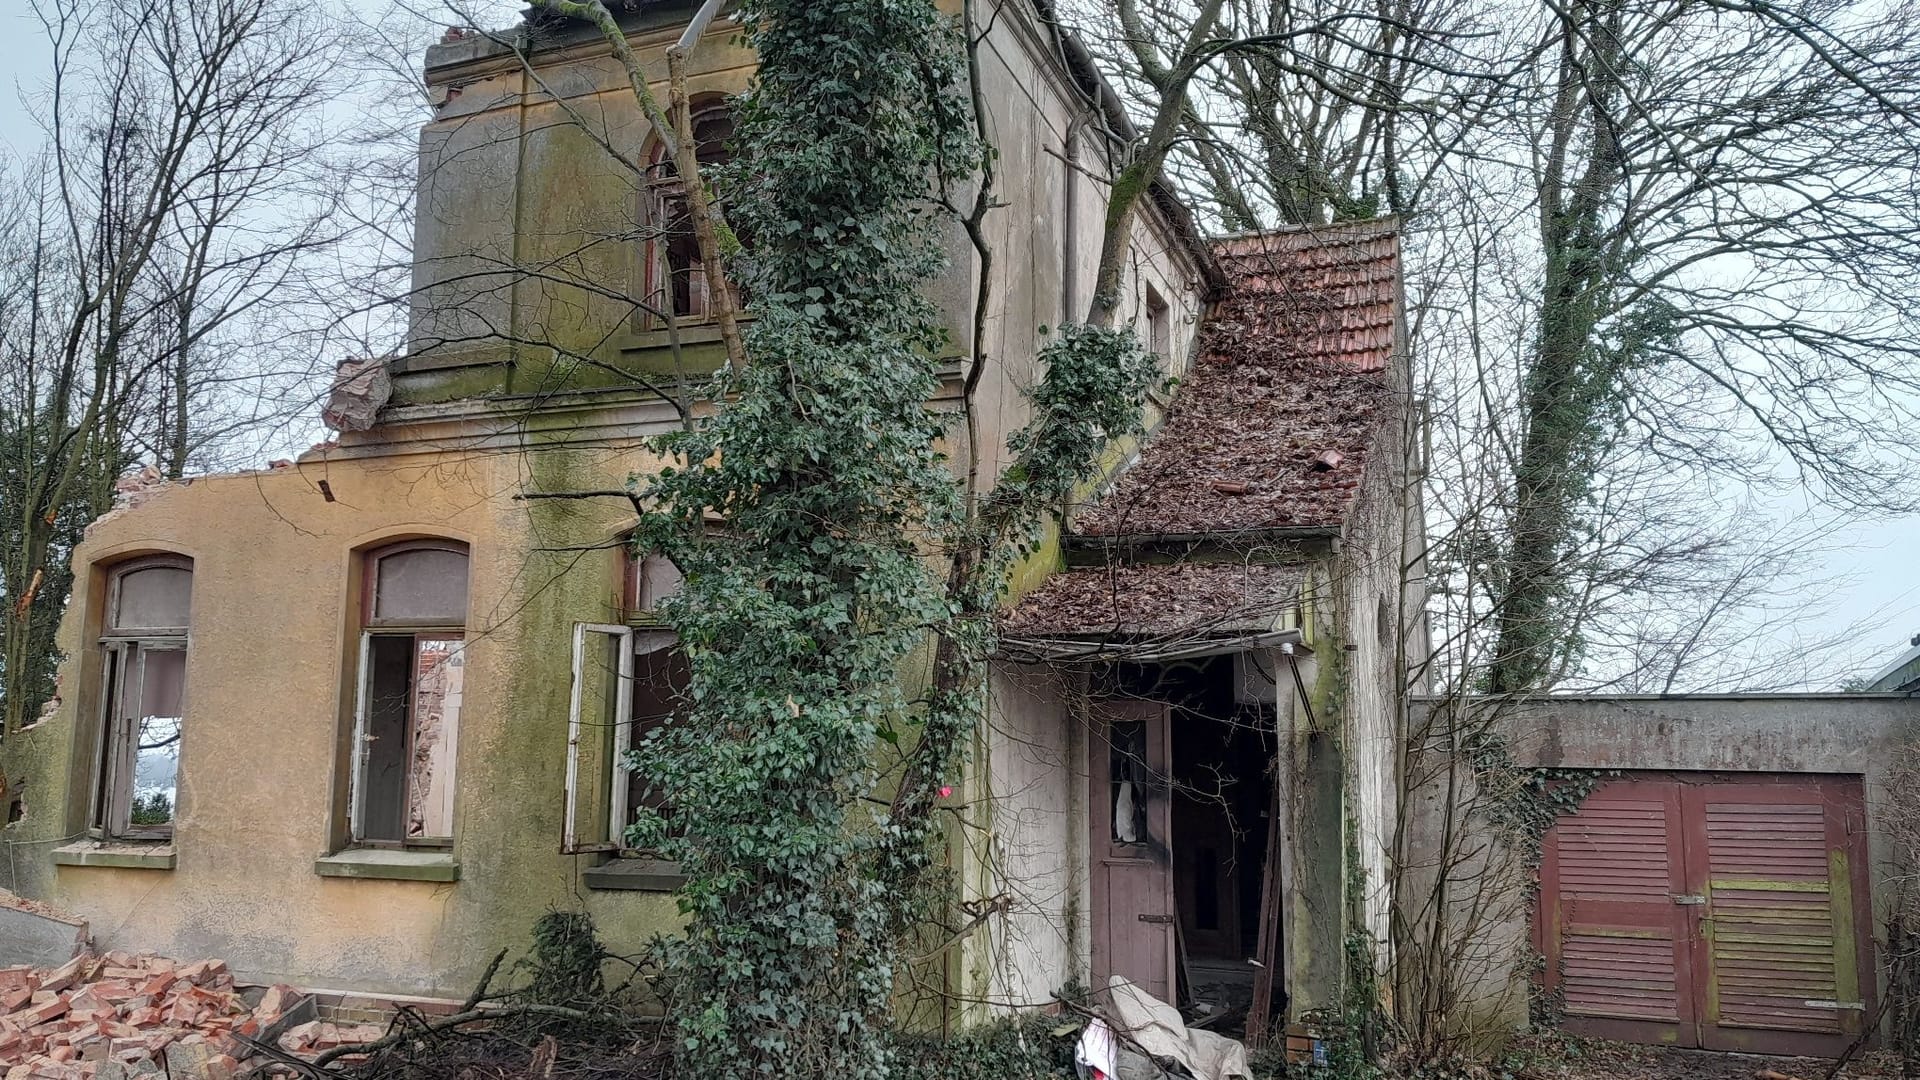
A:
0,434,691,995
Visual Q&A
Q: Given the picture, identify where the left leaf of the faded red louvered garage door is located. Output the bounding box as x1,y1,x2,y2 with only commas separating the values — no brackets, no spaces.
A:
1540,780,1697,1045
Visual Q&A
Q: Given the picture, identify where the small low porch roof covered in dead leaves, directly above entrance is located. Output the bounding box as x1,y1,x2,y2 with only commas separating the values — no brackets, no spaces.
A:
1000,563,1304,640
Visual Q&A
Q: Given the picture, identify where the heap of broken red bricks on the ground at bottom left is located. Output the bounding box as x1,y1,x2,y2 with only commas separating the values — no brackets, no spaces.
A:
0,953,386,1080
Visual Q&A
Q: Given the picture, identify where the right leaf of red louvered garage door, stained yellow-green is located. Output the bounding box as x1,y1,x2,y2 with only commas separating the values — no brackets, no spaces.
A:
1682,776,1872,1055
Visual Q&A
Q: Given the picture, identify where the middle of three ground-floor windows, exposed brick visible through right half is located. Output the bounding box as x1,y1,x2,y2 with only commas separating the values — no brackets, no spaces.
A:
348,540,467,846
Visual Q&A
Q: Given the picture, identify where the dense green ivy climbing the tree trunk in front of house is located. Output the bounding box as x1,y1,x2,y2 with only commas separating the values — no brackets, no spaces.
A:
628,0,1154,1080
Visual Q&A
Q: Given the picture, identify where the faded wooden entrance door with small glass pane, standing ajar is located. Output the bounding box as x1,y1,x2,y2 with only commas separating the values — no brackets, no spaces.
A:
1087,701,1177,1003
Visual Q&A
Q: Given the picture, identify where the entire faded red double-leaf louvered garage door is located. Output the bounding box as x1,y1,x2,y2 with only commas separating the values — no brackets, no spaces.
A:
1536,773,1872,1055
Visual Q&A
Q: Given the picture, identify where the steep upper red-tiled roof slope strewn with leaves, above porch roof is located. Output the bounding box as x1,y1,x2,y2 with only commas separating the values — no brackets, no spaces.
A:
1073,219,1400,536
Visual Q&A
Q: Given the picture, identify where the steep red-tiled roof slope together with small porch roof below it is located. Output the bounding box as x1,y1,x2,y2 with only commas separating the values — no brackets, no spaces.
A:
1002,219,1404,645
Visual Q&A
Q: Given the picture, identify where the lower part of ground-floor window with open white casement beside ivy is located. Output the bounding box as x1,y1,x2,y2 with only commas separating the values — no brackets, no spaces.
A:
563,623,689,851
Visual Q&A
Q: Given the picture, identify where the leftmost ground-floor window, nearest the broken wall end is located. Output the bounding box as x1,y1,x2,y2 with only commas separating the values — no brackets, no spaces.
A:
88,555,194,840
